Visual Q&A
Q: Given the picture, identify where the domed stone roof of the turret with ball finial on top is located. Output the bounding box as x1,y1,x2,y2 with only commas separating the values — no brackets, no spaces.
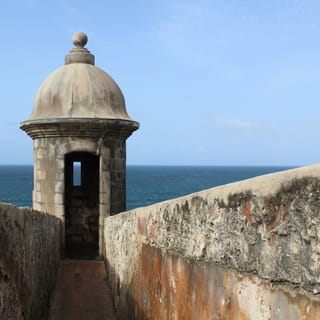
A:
26,32,132,122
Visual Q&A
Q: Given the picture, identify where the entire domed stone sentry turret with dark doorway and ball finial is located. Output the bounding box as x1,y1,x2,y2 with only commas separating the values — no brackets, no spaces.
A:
21,32,139,256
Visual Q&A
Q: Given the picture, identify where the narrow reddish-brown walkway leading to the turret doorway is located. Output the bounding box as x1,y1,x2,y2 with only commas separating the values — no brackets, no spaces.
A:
49,260,116,320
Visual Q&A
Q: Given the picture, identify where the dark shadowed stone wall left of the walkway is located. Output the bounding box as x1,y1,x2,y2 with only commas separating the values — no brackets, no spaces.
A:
0,203,61,320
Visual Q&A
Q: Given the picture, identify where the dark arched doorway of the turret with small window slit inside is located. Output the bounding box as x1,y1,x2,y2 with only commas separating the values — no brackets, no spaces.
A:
65,152,99,259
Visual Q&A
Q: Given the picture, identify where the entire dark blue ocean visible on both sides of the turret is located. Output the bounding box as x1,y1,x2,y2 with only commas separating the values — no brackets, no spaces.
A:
0,165,292,210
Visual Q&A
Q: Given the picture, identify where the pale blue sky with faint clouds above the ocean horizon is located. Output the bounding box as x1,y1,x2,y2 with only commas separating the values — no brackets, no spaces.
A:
0,0,320,166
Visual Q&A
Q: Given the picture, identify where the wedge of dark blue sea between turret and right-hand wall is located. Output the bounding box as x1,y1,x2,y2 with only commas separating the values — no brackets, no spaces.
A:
127,166,289,209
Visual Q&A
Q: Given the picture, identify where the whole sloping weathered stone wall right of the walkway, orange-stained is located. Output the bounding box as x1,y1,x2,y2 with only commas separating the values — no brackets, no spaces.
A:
104,165,320,319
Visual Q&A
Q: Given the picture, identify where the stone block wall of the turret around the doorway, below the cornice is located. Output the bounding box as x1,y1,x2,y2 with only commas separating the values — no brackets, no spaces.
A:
33,134,126,254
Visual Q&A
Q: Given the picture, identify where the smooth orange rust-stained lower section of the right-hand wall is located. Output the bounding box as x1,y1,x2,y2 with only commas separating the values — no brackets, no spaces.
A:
127,244,320,320
